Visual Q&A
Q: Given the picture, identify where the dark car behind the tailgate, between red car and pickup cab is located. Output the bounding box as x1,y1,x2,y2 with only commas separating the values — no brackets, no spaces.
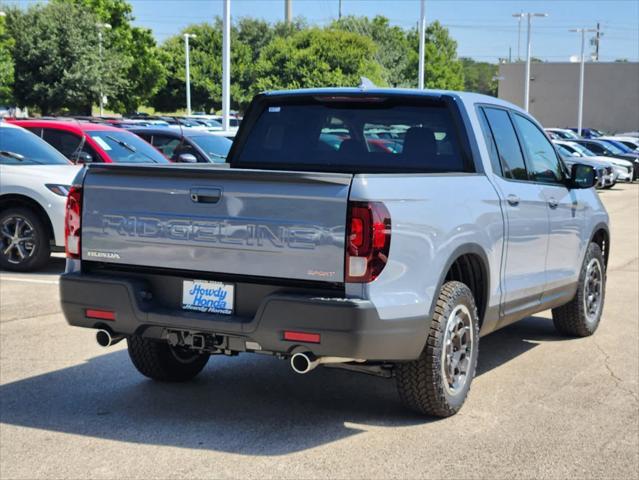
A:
129,127,233,163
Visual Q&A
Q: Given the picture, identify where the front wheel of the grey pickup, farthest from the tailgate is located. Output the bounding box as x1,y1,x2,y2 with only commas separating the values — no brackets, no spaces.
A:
552,243,606,337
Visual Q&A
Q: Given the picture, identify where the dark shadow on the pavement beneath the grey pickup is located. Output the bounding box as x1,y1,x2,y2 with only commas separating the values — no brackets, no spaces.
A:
0,317,559,455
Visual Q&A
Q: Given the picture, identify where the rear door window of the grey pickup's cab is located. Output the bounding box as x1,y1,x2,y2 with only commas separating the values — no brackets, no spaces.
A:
482,107,528,180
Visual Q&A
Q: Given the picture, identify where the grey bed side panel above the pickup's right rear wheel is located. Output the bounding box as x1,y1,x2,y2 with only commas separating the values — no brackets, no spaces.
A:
347,174,504,334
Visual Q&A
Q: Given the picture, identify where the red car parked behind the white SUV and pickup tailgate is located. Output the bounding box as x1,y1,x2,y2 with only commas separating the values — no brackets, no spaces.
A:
12,120,169,163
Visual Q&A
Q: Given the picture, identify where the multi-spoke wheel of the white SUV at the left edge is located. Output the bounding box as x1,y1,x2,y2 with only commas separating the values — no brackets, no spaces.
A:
0,207,51,272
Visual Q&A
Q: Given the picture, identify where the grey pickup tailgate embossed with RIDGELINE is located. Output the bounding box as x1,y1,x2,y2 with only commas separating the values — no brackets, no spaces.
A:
81,165,352,282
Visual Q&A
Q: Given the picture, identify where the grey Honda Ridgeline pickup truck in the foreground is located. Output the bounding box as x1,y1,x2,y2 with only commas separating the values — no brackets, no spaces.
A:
60,88,610,416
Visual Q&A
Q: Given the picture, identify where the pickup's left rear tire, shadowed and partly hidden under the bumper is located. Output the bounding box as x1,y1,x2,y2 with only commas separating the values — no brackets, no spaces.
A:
127,335,209,382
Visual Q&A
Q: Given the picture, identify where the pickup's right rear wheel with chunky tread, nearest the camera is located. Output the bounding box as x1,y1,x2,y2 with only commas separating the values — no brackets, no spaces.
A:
396,282,479,417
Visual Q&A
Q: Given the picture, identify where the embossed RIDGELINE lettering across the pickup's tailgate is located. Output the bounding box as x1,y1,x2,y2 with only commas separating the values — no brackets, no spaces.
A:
101,215,331,250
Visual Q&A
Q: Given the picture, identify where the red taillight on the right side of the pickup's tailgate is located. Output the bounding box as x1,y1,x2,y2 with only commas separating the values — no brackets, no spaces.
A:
346,202,391,283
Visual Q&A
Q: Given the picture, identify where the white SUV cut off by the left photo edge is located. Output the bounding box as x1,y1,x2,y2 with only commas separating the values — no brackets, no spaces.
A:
0,122,81,271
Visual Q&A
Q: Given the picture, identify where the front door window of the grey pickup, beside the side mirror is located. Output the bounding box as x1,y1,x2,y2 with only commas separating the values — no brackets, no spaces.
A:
513,114,564,183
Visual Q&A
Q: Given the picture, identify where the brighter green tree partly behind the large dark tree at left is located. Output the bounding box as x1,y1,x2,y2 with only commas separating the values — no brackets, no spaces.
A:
54,0,166,112
